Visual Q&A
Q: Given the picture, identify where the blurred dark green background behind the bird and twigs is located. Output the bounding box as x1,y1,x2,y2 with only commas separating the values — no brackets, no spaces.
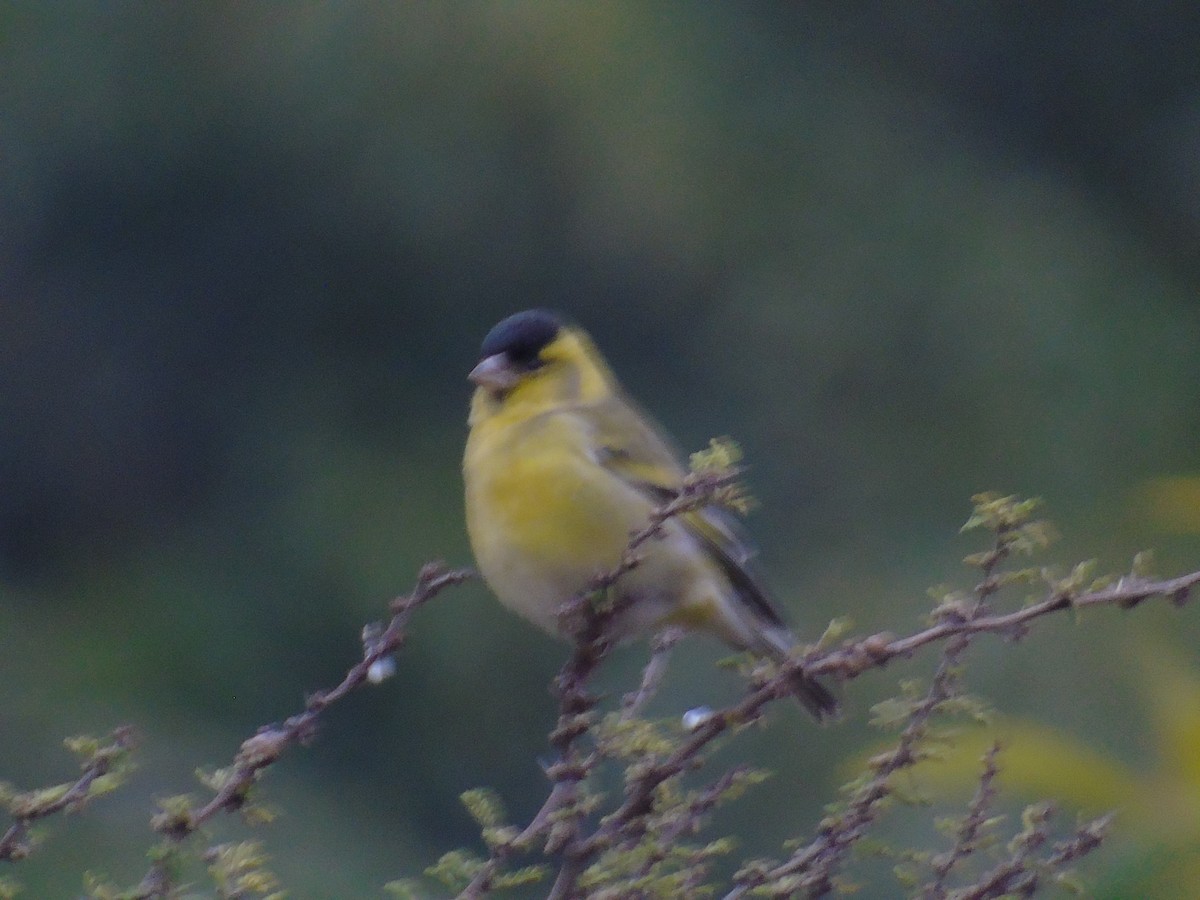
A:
0,2,1200,898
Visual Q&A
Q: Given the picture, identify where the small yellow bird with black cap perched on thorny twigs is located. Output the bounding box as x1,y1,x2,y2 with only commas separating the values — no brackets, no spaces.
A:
463,308,839,721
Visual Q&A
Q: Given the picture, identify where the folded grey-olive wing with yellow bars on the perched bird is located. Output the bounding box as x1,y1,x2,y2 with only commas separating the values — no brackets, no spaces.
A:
581,396,787,630
